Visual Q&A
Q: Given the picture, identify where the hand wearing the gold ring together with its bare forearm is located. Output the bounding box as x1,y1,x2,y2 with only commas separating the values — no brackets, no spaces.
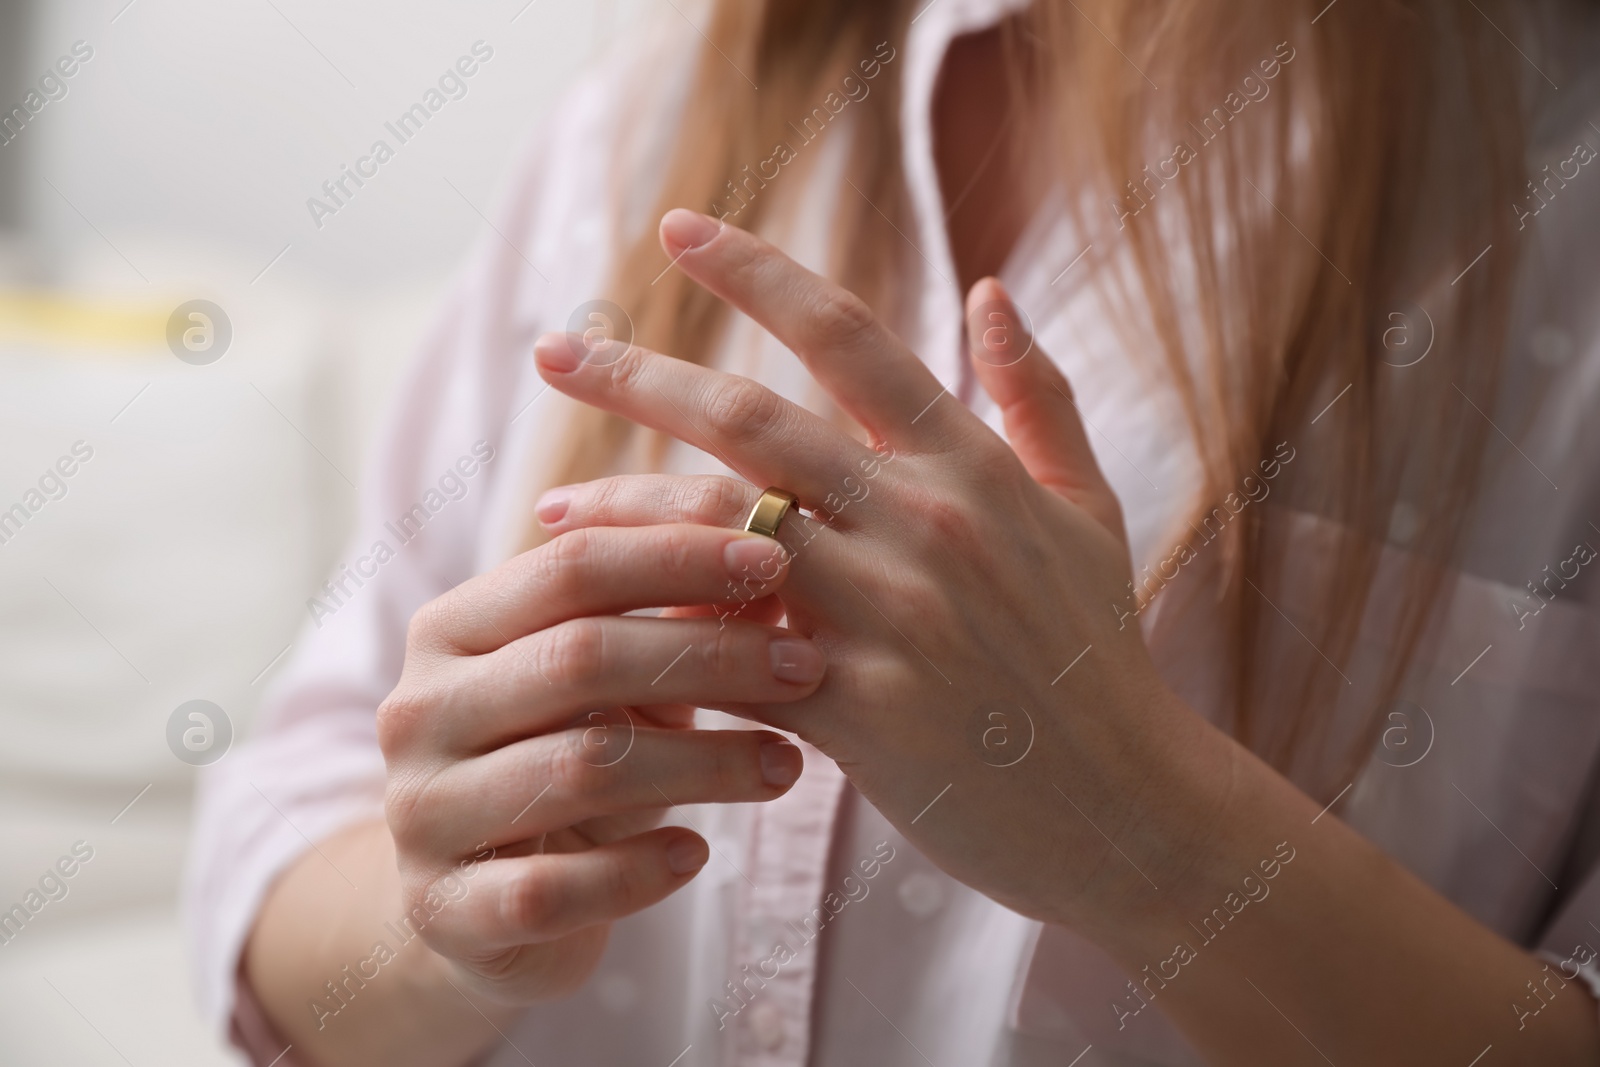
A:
536,211,1600,1067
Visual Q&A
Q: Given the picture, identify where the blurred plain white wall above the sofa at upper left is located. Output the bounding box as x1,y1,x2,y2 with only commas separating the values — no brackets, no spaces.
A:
15,0,642,294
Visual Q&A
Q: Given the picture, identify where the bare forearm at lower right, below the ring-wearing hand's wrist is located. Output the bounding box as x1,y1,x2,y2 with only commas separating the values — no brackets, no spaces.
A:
1102,697,1600,1067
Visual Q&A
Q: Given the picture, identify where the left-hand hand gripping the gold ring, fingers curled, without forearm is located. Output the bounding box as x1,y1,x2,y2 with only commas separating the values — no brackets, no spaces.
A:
378,526,824,1008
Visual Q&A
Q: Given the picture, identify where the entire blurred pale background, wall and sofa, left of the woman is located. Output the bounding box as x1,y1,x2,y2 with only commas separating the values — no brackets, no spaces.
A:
0,0,643,1067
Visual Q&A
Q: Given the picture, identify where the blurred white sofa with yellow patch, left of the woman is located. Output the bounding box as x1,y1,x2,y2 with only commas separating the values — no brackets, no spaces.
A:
0,238,435,1065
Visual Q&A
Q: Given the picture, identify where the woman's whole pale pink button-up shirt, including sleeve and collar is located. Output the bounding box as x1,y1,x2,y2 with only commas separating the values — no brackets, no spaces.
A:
187,0,1600,1067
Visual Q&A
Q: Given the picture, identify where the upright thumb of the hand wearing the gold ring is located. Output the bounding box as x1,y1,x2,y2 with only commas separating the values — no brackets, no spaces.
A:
966,278,1126,541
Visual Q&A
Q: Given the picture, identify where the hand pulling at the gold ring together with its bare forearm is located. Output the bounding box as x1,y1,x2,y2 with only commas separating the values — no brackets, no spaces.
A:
243,525,826,1067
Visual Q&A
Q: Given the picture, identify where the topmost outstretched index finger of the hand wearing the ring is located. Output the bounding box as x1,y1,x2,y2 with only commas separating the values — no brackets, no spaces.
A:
661,208,974,448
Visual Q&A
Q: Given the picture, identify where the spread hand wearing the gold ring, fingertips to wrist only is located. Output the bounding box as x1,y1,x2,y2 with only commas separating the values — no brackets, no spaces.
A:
536,211,1234,933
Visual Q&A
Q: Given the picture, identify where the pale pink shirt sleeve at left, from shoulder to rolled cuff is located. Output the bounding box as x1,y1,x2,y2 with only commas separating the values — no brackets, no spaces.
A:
182,40,690,1067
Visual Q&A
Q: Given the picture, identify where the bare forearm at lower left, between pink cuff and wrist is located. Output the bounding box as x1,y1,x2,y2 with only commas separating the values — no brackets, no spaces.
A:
245,822,517,1067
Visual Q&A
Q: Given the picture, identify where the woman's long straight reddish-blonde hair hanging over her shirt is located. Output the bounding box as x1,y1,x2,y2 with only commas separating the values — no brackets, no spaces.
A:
531,0,1525,795
